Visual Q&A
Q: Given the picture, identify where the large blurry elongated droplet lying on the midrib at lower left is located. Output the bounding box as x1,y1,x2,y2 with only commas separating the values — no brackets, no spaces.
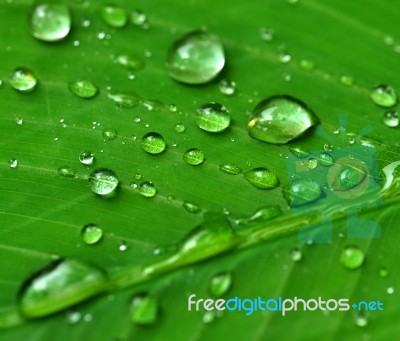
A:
19,259,107,318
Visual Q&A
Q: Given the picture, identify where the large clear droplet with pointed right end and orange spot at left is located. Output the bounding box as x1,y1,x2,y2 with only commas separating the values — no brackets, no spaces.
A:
248,96,318,144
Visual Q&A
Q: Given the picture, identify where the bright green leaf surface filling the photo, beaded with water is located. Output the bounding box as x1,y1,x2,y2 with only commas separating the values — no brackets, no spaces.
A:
0,0,400,341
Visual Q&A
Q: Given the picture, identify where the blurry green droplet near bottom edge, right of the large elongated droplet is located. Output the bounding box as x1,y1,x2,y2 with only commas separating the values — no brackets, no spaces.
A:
131,294,158,325
